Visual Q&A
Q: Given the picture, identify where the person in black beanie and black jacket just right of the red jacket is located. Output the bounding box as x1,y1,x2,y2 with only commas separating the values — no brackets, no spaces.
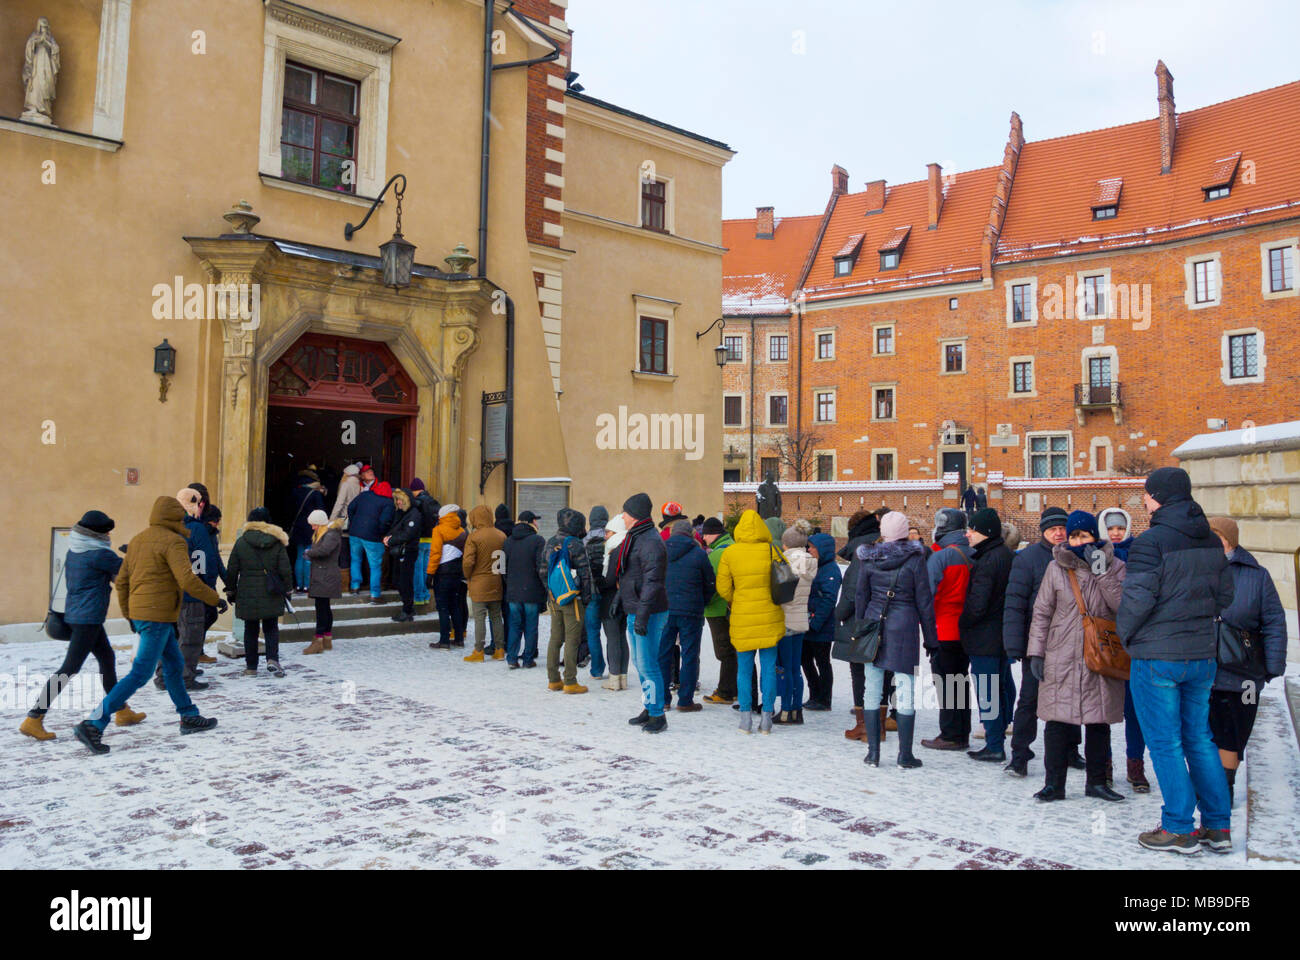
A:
957,507,1015,764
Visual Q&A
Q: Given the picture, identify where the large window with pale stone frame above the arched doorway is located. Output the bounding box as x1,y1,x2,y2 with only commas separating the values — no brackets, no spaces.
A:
257,0,400,196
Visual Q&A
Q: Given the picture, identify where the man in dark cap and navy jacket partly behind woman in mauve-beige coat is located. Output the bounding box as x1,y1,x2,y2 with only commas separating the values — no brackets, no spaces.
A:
1002,507,1083,777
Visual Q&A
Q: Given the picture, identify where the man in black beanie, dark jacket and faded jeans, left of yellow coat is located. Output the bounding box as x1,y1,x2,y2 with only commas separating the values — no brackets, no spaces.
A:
610,493,668,734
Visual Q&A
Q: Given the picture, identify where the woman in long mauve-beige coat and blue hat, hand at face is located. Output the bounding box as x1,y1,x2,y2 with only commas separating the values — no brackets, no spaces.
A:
1028,510,1125,801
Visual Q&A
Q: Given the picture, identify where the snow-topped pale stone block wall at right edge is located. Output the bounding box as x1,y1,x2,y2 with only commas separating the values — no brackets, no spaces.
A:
1174,420,1300,642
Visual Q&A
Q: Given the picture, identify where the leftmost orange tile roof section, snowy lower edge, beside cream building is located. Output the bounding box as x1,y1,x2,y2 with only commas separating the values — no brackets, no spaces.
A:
723,215,822,316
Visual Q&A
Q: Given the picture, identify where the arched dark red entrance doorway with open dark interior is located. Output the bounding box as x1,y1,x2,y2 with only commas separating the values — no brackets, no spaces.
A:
263,333,420,532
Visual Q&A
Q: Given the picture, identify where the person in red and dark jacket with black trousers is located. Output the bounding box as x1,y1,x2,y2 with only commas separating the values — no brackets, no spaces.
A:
920,507,972,751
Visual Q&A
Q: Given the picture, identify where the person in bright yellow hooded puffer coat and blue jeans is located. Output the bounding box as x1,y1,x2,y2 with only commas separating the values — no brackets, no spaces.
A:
718,510,785,734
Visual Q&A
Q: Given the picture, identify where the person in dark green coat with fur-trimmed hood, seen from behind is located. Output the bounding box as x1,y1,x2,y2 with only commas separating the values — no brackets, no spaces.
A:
226,507,293,678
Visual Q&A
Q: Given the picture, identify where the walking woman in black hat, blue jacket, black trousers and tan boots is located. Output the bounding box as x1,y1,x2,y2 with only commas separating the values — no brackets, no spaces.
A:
18,510,144,740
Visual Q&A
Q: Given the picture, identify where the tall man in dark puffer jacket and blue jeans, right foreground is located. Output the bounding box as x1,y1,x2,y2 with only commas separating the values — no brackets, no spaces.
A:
1115,467,1232,853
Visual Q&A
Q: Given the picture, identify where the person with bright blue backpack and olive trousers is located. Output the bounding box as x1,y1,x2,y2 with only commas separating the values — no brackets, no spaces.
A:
537,507,592,693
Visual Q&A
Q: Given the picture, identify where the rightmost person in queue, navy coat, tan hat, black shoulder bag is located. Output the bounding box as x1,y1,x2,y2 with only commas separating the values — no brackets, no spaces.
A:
1210,516,1287,803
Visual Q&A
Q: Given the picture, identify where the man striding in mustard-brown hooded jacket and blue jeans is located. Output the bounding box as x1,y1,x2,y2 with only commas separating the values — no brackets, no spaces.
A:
73,497,226,753
